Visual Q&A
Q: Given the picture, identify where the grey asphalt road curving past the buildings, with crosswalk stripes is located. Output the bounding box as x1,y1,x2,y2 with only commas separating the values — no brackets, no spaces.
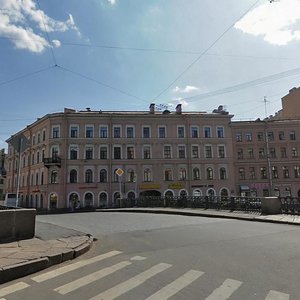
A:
0,212,300,300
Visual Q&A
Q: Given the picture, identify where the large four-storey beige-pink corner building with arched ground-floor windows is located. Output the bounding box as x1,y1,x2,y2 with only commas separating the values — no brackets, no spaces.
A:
7,104,237,208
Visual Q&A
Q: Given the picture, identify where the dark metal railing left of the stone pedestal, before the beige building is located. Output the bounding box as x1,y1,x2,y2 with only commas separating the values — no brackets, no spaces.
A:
115,196,261,213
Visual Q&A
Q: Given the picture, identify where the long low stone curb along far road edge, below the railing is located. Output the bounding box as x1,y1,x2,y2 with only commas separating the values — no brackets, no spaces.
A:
97,208,300,226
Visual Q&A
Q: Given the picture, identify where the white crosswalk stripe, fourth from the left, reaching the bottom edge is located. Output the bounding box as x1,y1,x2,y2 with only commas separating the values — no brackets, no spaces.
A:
90,263,172,300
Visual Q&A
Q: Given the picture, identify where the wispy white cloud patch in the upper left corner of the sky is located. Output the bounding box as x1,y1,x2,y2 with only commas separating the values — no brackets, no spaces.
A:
0,0,80,53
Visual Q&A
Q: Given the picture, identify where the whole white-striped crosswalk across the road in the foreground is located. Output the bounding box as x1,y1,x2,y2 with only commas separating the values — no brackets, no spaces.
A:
0,250,290,300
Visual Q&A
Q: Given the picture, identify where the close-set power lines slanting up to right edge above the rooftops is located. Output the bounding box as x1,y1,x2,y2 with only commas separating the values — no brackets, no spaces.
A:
182,68,300,102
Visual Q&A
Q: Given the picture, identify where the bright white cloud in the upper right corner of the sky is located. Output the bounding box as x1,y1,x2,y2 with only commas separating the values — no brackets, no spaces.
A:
234,0,300,46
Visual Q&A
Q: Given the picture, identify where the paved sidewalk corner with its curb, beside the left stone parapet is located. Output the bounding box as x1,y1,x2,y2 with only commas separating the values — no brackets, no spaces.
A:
0,222,93,284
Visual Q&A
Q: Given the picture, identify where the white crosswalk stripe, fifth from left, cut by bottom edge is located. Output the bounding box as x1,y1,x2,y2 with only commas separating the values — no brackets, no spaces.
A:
146,270,204,300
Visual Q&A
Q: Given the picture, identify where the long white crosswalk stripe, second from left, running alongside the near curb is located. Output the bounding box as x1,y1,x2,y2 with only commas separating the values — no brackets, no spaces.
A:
31,250,122,282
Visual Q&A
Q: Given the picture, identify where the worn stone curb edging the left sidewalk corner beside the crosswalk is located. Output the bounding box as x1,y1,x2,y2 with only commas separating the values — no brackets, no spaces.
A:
0,234,93,284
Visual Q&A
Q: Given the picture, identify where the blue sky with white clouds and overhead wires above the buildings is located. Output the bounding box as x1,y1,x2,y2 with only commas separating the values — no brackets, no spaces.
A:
0,0,300,149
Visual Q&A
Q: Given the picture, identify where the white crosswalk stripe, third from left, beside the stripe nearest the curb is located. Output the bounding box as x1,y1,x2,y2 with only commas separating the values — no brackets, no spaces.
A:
54,261,132,295
